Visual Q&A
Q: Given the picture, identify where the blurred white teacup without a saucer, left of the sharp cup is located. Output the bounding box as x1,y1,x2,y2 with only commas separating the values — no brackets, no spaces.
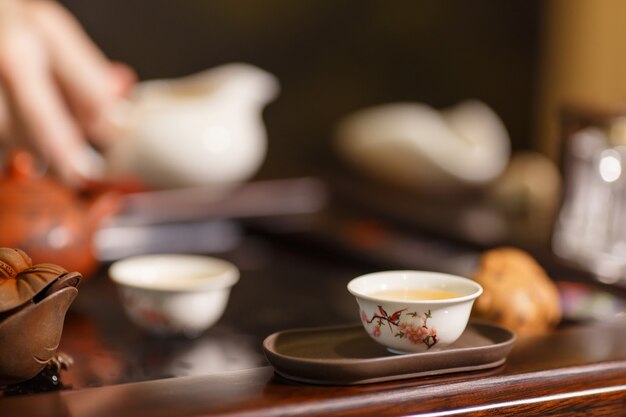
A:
109,254,239,337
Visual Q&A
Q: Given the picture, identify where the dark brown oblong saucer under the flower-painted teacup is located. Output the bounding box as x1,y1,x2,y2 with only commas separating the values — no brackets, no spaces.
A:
263,323,515,385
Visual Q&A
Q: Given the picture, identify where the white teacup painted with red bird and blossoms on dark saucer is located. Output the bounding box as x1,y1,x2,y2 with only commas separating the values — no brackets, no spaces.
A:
348,271,483,353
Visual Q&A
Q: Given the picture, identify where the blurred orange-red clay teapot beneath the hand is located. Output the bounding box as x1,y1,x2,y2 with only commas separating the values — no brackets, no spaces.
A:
0,151,118,276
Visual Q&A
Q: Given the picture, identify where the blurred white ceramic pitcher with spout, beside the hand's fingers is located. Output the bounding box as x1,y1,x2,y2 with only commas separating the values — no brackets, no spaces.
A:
105,64,279,188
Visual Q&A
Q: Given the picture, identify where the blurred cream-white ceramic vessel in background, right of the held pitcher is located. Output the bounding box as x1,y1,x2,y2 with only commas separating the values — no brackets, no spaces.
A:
336,100,511,192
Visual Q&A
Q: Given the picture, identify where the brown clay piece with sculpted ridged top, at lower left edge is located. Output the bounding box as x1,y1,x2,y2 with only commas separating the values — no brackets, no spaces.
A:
0,248,81,386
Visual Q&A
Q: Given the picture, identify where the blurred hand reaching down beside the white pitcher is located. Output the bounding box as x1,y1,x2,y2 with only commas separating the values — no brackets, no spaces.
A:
0,0,135,185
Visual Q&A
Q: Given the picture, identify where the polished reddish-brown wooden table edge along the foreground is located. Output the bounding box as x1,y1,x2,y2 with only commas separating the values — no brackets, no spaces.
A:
0,323,626,417
